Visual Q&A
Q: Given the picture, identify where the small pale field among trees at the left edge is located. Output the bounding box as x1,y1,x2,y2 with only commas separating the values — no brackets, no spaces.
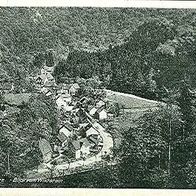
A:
3,93,33,105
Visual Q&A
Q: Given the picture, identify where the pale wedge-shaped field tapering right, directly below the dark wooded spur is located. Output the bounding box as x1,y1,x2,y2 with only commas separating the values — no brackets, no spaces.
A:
105,90,163,109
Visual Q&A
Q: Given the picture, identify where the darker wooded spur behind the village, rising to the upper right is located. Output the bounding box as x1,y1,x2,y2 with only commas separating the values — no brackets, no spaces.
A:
56,10,196,99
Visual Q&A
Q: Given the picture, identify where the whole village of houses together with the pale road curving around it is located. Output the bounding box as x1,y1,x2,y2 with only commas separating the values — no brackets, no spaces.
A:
27,66,114,176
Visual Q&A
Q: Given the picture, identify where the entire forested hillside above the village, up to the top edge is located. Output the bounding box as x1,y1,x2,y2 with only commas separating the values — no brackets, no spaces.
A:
0,8,196,98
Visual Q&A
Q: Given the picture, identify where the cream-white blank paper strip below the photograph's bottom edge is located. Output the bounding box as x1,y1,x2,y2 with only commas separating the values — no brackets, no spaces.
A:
0,188,196,196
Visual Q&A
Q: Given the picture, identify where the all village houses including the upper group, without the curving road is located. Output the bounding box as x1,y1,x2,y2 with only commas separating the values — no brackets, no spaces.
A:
30,66,113,162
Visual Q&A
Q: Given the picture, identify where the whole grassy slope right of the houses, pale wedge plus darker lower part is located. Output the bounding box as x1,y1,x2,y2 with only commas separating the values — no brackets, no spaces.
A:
103,90,164,148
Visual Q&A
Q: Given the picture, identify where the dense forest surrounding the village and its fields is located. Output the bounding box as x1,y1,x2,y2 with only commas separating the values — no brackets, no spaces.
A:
0,8,196,188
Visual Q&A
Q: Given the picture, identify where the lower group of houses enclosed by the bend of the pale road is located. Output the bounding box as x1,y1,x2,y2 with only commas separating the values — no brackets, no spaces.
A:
54,123,103,162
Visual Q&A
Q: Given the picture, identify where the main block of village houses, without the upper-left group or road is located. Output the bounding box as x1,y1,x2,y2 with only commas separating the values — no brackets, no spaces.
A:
50,95,107,162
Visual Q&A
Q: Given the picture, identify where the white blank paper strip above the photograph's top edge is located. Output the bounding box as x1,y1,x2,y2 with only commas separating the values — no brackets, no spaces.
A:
0,0,196,8
